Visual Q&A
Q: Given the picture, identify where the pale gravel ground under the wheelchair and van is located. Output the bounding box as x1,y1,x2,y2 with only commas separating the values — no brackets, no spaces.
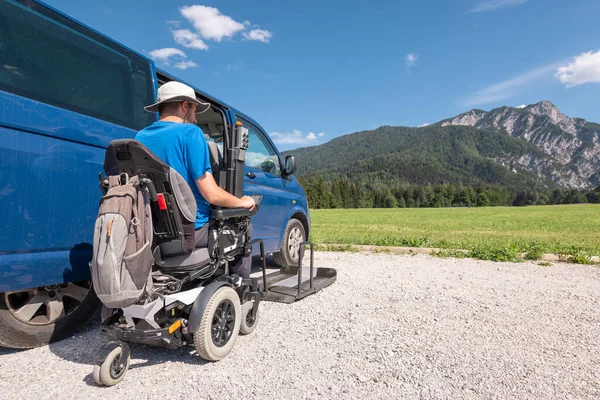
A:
0,252,600,400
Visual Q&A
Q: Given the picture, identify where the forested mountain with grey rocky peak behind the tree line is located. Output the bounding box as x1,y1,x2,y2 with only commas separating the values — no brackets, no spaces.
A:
286,101,600,190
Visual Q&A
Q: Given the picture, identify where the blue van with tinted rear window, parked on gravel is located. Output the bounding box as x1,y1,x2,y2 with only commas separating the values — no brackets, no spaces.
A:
0,0,310,348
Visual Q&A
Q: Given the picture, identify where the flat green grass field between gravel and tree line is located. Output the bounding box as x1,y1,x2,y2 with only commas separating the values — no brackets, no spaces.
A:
311,204,600,263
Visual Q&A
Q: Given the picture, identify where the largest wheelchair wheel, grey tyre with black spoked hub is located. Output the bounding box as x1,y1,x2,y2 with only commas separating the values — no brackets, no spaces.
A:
194,286,242,361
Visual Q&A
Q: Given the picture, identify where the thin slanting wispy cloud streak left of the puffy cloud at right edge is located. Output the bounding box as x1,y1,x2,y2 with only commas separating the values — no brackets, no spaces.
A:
463,64,556,106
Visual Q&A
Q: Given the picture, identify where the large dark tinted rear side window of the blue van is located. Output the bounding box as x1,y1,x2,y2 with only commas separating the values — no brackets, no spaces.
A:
0,0,156,129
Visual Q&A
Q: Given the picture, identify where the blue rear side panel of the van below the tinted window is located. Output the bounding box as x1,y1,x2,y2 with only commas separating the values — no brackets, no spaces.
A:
0,95,135,292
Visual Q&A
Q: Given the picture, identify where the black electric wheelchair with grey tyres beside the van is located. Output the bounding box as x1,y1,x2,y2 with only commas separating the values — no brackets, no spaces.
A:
93,127,267,386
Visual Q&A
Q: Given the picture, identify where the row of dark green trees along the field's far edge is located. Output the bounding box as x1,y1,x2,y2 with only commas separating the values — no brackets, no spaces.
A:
299,176,600,209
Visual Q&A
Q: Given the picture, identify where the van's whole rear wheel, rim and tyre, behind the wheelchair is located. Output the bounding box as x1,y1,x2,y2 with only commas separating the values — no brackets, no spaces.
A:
0,281,100,349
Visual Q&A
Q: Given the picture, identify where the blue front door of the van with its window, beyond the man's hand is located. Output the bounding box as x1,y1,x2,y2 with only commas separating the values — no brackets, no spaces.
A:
237,117,292,252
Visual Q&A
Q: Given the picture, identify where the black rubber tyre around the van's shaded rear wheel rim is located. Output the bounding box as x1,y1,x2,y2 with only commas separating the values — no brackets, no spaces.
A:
0,282,100,349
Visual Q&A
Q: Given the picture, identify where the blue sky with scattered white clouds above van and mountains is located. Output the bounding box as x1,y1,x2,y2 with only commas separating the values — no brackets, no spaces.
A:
47,0,600,149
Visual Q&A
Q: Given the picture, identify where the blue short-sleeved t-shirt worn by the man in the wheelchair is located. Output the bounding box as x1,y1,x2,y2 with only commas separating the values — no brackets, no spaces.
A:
135,121,212,229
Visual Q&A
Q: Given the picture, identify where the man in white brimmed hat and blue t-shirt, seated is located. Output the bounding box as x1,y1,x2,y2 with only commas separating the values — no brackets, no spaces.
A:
135,82,255,278
